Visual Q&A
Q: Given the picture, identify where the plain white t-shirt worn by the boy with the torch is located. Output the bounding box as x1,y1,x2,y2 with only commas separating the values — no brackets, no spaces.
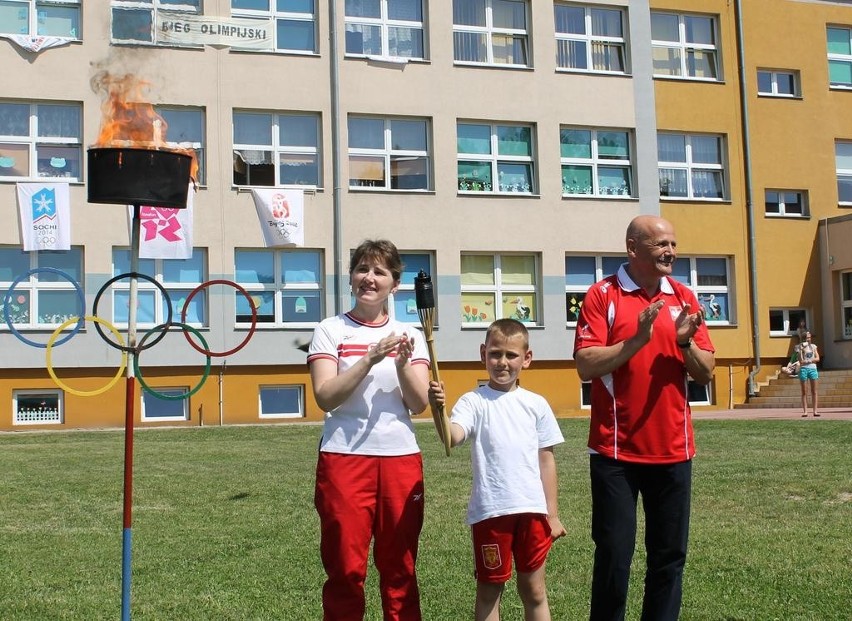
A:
450,385,565,524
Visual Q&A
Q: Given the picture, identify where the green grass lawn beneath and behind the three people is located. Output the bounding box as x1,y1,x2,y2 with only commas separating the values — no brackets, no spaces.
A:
0,419,852,621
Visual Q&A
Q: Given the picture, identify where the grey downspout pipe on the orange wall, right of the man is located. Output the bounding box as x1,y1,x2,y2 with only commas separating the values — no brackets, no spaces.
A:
735,0,760,397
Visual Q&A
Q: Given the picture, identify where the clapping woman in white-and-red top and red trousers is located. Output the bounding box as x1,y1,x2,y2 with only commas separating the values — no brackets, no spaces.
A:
308,240,429,621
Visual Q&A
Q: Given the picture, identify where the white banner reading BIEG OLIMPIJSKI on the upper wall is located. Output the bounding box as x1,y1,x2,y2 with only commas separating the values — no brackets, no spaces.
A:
155,11,274,51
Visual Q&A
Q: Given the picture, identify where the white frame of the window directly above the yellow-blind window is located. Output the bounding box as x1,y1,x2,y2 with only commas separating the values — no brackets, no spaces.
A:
456,121,538,196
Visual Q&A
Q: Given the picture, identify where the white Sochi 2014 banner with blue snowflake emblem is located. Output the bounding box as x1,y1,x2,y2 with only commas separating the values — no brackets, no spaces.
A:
17,183,71,252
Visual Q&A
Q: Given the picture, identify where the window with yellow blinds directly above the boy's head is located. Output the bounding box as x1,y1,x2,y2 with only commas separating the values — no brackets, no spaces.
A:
461,254,541,327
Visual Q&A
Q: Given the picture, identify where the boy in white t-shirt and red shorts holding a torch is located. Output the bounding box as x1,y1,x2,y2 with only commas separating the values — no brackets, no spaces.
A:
429,319,565,621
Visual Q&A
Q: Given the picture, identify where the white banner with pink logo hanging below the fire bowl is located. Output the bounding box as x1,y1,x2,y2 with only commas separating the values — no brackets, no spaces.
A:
128,184,195,259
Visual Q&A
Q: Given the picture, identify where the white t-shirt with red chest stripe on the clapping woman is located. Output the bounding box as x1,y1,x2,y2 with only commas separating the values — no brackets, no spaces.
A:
308,313,429,456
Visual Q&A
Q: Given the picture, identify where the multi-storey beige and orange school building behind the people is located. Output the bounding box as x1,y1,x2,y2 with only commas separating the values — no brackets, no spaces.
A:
0,0,852,430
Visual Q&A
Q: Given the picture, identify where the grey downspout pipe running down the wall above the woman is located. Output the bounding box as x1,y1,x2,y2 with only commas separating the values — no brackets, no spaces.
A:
328,0,349,315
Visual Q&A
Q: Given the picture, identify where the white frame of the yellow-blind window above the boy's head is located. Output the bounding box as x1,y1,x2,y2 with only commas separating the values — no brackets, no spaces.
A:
459,252,544,329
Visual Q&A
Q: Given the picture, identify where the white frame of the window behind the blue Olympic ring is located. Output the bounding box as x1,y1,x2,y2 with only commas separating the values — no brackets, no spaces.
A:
0,246,85,332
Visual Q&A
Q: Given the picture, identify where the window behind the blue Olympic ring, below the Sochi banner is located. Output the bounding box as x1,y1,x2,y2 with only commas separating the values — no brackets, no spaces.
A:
0,247,85,329
